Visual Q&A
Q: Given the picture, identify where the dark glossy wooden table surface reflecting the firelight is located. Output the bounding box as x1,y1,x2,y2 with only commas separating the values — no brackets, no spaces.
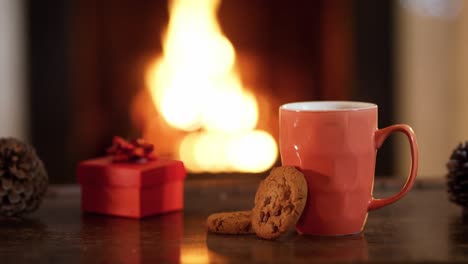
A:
0,177,468,264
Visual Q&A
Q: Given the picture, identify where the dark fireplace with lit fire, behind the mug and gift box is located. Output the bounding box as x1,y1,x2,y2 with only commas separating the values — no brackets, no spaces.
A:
28,0,392,182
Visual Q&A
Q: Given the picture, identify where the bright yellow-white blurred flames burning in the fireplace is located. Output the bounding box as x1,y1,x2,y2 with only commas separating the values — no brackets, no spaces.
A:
146,0,278,172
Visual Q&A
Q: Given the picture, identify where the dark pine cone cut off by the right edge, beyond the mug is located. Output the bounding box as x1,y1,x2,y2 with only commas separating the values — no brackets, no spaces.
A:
447,141,468,207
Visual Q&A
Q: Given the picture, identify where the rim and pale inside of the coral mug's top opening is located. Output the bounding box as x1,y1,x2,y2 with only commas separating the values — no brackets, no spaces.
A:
280,101,377,112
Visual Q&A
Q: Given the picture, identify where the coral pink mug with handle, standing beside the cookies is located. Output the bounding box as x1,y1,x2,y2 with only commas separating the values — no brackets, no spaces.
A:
280,101,418,236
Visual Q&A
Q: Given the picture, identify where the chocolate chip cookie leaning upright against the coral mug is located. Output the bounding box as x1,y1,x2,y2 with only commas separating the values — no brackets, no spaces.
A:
252,166,307,239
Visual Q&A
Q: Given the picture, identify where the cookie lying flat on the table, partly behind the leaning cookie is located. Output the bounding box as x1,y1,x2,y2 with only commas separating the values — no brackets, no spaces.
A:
206,211,254,235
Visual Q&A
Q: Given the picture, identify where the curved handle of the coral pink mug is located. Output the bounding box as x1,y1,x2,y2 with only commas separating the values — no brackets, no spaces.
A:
368,124,419,211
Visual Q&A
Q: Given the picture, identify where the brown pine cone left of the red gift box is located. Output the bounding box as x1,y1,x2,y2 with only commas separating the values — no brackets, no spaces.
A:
0,138,48,216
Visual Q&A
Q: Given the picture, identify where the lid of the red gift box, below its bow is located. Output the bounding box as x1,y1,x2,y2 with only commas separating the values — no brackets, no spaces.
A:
77,157,186,188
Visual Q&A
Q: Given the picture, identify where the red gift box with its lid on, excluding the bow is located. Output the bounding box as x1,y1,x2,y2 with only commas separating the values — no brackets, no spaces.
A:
77,157,186,218
